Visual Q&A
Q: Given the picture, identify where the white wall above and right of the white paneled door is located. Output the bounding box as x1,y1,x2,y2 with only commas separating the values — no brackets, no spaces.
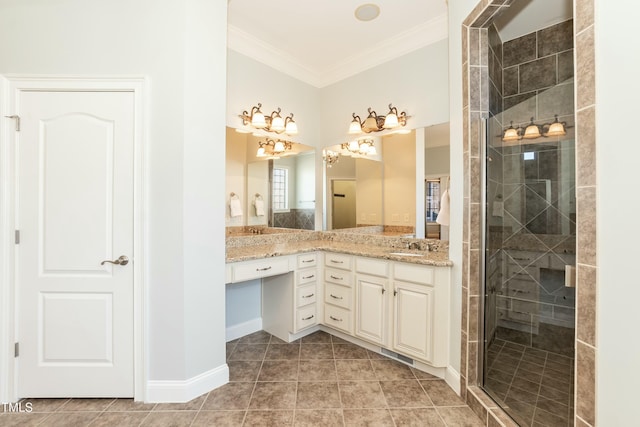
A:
0,0,227,388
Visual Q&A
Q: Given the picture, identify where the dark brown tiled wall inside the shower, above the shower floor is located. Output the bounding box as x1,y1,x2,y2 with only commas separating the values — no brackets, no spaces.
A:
485,19,576,357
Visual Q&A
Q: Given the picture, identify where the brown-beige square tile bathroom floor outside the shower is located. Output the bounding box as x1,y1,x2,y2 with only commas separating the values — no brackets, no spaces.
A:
0,332,483,427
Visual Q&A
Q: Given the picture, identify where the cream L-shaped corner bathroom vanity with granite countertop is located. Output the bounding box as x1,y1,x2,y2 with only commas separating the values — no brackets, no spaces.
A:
226,232,451,375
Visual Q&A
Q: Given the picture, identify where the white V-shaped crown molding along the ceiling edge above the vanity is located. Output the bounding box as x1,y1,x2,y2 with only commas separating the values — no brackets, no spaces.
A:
228,14,448,88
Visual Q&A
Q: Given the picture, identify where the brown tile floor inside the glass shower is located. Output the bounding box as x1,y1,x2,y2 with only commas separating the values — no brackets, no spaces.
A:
485,339,574,427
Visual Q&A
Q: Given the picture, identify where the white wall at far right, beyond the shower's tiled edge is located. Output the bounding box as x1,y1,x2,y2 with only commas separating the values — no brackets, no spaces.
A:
595,0,640,426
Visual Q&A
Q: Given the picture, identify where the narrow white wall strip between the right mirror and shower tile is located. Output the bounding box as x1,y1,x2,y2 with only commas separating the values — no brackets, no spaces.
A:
443,0,478,382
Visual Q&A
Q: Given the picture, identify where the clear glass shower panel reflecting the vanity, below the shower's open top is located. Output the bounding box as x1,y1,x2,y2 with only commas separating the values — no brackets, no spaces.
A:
483,117,576,426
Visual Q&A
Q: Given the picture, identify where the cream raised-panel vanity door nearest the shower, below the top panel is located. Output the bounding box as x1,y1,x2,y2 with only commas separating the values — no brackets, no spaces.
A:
393,282,434,362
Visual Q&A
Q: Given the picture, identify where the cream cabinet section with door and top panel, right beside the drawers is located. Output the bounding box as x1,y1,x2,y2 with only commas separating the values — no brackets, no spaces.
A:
355,257,389,347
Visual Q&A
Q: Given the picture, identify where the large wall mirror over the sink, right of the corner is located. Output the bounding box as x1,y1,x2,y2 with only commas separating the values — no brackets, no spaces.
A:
323,123,449,240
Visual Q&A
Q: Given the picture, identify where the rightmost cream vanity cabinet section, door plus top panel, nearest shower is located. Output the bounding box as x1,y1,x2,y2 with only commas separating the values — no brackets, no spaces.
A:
392,263,450,367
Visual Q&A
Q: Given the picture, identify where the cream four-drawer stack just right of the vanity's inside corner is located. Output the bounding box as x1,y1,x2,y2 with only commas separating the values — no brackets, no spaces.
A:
323,252,354,335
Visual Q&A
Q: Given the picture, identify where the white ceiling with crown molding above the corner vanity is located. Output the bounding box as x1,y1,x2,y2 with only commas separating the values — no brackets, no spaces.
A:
228,0,448,87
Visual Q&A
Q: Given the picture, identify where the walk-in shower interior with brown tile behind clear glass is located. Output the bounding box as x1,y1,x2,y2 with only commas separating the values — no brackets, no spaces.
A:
479,0,576,426
